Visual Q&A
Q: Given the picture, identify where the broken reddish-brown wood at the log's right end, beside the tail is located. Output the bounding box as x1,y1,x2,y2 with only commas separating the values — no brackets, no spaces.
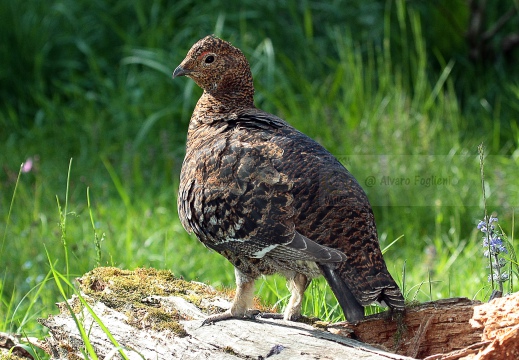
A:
329,293,519,360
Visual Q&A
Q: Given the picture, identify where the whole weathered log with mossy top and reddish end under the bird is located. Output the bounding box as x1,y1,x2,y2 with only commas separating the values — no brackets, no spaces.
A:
27,268,519,360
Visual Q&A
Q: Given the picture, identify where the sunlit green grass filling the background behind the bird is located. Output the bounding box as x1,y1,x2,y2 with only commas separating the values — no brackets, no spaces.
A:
0,0,519,354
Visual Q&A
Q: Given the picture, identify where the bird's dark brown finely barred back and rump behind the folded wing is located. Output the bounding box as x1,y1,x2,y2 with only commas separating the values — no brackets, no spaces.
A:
241,110,403,308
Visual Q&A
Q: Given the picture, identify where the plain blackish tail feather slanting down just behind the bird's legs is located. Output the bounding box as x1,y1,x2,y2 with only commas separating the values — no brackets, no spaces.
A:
319,264,364,323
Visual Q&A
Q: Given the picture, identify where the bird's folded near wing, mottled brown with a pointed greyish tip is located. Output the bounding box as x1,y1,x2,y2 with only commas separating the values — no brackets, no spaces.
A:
178,117,346,263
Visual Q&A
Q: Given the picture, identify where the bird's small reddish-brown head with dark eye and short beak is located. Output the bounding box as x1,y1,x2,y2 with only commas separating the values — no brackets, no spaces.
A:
173,35,254,105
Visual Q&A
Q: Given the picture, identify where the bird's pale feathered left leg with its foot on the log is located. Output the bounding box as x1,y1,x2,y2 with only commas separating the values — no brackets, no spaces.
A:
203,268,259,325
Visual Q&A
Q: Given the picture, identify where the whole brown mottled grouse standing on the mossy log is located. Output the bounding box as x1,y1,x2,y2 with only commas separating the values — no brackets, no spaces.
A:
173,35,405,324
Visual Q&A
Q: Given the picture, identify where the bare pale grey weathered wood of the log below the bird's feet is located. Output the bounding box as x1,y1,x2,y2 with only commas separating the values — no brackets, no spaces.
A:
36,298,412,360
